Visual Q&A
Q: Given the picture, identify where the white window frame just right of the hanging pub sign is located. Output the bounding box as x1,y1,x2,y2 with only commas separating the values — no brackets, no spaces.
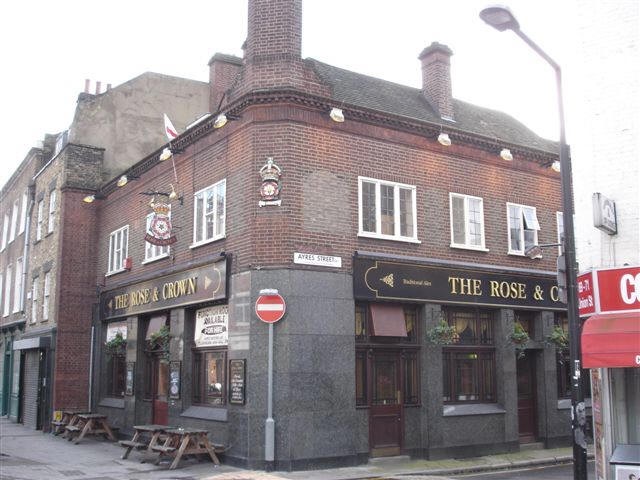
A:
190,179,227,248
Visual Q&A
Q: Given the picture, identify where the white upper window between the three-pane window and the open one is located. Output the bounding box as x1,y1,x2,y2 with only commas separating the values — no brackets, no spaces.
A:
449,193,485,249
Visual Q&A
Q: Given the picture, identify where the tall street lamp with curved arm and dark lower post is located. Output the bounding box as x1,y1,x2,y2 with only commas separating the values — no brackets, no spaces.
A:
480,6,587,480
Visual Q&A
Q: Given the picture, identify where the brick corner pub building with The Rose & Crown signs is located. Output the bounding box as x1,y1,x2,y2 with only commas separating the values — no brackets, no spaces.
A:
76,0,571,469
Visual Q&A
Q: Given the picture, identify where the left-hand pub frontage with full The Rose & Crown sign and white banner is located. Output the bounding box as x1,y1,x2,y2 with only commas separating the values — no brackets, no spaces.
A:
92,256,229,444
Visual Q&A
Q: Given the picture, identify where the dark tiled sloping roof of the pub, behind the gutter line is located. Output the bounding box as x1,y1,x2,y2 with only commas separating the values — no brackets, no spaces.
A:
306,58,558,152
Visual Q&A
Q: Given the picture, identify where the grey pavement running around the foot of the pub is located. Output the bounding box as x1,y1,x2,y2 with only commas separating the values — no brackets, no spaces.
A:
0,417,592,480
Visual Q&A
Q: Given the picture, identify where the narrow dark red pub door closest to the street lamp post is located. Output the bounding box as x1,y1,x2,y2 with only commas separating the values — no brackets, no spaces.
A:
516,352,538,443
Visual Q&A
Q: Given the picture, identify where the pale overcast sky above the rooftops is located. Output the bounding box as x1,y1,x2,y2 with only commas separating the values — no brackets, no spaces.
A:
0,0,577,191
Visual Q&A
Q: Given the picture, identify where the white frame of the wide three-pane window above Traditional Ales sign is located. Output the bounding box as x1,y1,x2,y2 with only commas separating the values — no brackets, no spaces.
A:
358,177,421,243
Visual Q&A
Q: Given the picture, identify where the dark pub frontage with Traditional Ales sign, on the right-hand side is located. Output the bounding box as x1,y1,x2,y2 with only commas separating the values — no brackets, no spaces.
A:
353,253,570,458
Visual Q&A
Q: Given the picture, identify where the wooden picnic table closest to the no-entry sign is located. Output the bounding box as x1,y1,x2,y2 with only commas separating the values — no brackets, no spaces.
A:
151,428,220,470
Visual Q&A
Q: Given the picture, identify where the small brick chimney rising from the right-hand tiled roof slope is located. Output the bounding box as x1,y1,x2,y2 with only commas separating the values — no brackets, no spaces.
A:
418,42,454,120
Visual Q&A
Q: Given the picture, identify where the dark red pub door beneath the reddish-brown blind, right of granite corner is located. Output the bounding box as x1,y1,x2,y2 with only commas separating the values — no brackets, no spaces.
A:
369,351,403,457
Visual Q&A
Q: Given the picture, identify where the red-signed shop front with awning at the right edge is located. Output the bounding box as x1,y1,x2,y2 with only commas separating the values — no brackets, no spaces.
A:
578,267,640,480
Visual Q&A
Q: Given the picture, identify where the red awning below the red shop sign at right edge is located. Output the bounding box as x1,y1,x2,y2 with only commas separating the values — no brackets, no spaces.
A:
582,312,640,368
